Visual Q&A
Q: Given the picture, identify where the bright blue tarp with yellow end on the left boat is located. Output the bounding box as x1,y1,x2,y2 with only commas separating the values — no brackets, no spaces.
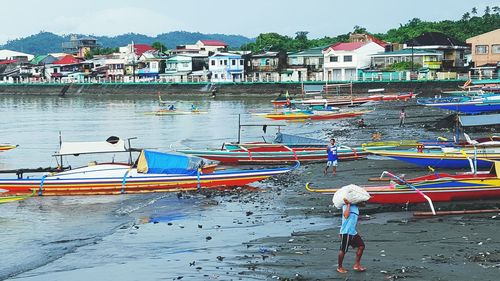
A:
137,150,203,175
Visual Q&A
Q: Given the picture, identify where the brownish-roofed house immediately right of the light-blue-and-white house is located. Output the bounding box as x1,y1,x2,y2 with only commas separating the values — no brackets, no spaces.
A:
245,51,287,82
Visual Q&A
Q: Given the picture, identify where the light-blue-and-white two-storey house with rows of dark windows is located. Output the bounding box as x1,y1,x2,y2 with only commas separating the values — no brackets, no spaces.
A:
208,53,245,82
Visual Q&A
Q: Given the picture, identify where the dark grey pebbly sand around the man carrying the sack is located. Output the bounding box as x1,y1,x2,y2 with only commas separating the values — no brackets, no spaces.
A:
228,99,500,281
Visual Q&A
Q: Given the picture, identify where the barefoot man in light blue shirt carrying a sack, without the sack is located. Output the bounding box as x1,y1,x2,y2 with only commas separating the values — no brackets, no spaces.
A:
337,198,366,273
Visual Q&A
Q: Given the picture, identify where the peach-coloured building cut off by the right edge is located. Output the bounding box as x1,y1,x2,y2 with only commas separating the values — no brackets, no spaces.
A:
466,28,500,77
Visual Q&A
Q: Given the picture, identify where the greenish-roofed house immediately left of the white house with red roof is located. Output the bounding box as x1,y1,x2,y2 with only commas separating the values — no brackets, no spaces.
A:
281,46,327,81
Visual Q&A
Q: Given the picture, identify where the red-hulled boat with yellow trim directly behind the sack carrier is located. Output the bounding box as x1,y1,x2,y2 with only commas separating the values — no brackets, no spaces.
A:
306,163,500,204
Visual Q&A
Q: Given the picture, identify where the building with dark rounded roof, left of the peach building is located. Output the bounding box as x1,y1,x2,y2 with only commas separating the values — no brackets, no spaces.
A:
404,32,470,71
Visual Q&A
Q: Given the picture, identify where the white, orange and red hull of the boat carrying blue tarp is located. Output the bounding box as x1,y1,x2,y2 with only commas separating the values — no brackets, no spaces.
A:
0,165,291,196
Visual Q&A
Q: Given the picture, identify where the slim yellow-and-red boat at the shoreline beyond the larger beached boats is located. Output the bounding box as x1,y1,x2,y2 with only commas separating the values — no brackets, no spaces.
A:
264,110,370,121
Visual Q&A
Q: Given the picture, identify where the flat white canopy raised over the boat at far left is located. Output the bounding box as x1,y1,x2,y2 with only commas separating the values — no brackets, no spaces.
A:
56,140,128,156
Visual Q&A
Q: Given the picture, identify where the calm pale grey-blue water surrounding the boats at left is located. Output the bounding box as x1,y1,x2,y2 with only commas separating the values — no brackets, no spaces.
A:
0,95,450,280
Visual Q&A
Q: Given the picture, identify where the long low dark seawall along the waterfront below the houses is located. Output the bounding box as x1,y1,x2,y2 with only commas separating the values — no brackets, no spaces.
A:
0,80,464,96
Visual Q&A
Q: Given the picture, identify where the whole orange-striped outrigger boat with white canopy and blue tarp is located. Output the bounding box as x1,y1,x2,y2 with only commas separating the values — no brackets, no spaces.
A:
0,139,299,196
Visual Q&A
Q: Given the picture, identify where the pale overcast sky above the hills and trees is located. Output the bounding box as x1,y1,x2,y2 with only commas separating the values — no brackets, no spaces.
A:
0,0,499,44
